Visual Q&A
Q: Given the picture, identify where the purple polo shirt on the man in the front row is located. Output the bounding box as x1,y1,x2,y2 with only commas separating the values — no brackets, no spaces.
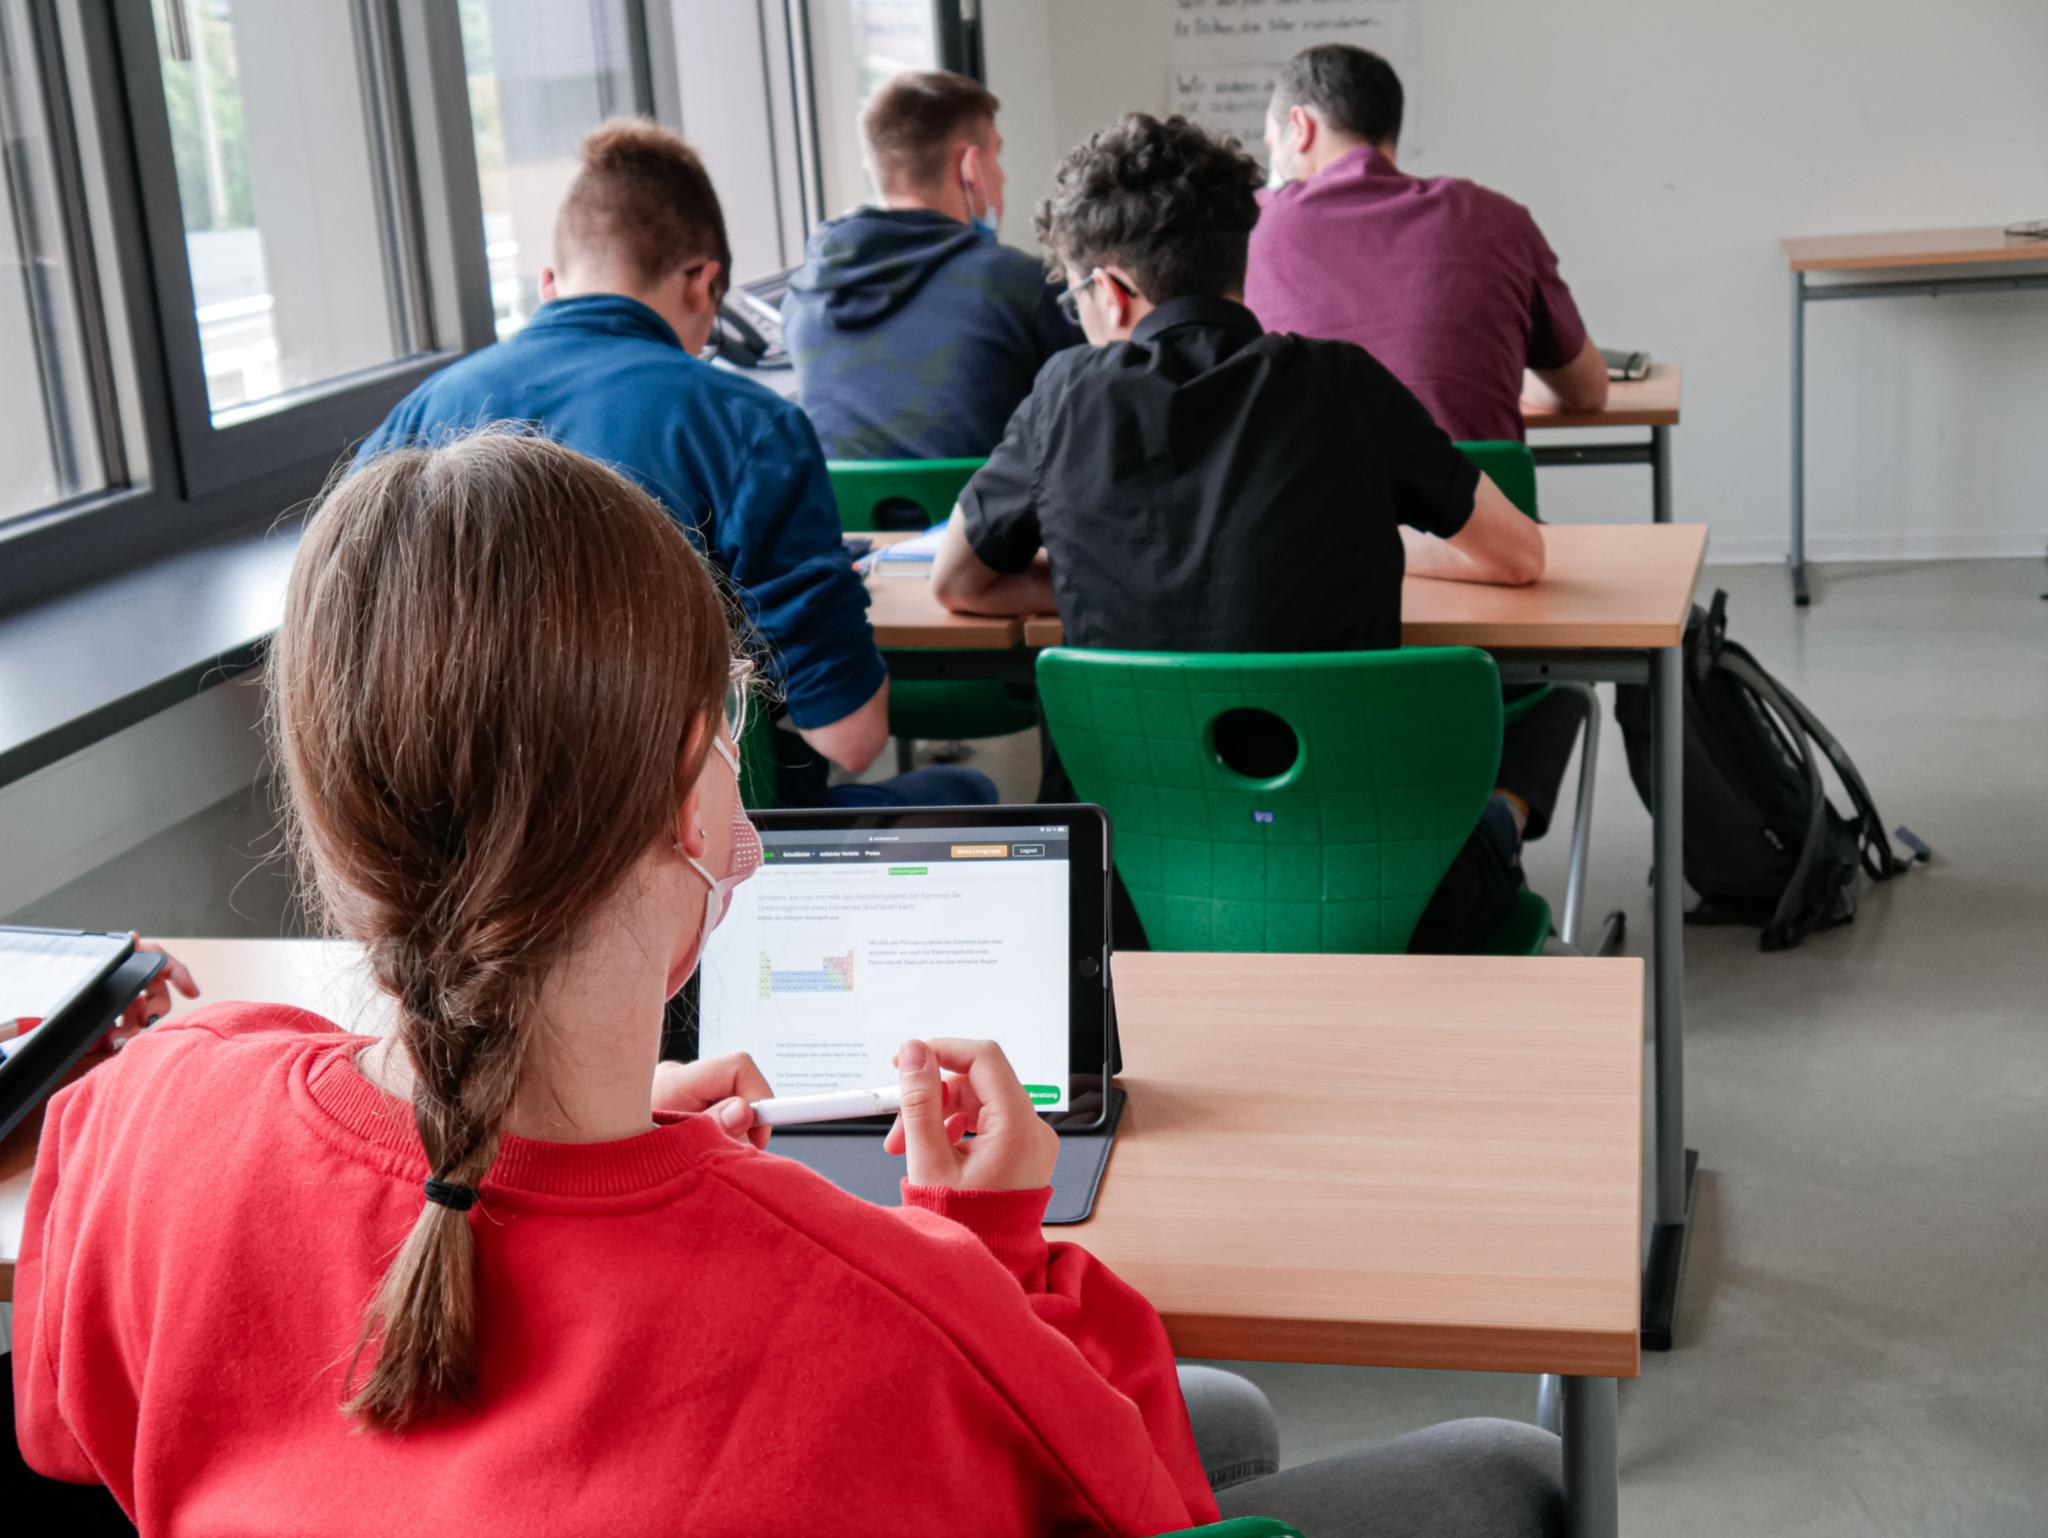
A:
1245,147,1585,440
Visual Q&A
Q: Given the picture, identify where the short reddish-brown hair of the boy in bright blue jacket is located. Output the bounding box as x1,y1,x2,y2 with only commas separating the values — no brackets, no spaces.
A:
555,117,733,287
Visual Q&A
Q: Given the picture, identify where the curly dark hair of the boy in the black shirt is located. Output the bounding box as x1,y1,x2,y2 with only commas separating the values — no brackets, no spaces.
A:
1036,113,1266,305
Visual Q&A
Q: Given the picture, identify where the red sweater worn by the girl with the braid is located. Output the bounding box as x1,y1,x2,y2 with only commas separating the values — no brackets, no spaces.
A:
14,1003,1217,1538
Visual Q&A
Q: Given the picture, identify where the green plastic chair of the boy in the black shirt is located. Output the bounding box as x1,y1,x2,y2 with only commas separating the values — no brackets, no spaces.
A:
1038,647,1550,954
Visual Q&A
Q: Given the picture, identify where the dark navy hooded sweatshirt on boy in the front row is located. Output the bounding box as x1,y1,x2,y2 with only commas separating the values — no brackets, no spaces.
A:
782,209,1083,459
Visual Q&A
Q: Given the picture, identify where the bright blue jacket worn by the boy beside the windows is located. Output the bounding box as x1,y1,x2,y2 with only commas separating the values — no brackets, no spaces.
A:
356,295,883,741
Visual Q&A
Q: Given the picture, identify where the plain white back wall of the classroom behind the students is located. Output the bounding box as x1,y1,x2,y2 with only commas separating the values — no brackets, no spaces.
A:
985,0,2048,561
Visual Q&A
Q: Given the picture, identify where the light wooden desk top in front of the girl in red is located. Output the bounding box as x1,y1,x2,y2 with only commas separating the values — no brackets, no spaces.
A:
0,940,1642,1376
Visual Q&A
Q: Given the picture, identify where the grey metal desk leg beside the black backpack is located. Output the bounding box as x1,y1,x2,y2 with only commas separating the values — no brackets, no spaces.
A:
1642,647,1698,1352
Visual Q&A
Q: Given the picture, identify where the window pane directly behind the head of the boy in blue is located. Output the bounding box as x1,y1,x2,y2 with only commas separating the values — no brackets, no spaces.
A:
461,0,637,336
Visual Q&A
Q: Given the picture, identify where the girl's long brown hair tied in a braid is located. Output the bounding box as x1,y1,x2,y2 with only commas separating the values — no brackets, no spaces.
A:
268,432,733,1429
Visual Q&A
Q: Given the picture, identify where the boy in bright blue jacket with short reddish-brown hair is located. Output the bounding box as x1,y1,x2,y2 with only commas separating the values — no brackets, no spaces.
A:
356,121,995,807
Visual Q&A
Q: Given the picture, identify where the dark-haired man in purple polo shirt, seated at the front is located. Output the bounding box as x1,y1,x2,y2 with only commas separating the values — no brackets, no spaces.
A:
1245,43,1608,440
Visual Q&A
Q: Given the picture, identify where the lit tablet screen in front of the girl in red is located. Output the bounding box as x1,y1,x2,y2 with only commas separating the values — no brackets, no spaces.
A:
698,813,1100,1112
